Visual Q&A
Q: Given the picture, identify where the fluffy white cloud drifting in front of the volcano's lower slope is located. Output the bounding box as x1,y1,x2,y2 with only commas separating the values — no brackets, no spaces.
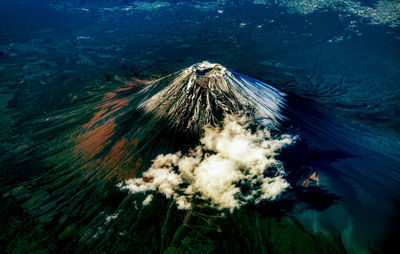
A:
118,116,295,211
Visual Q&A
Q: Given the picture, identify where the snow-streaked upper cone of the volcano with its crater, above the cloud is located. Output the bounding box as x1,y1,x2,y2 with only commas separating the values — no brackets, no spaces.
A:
139,61,285,133
